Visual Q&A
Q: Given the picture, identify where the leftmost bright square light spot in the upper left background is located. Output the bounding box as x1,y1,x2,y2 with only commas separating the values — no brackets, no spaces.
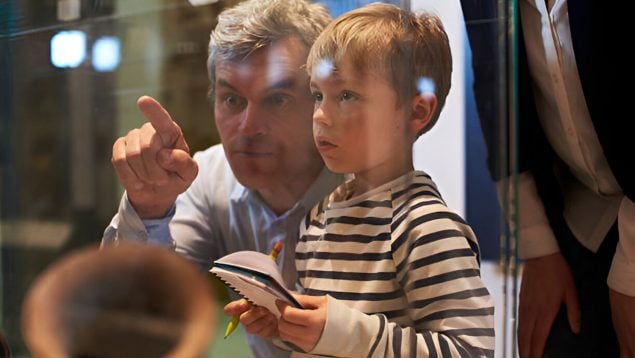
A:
51,30,86,68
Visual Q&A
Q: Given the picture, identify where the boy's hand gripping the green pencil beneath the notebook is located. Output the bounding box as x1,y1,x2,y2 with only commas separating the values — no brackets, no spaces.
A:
223,299,278,338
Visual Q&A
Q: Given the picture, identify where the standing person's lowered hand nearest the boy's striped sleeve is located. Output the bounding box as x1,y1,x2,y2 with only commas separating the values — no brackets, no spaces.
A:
518,253,580,358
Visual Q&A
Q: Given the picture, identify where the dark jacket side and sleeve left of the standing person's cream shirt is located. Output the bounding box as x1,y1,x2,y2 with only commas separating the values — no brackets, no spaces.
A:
461,0,564,232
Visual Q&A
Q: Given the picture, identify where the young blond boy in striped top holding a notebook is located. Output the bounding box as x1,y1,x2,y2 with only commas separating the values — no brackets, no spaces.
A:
248,3,494,357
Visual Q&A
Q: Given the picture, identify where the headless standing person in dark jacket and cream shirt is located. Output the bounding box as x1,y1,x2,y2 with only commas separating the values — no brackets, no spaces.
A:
462,0,635,357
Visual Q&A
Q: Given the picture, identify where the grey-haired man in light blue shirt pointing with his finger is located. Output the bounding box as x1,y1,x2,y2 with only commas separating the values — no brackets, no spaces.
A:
103,0,342,357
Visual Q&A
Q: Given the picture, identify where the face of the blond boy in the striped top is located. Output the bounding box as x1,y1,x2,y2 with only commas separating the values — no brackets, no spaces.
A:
311,58,416,186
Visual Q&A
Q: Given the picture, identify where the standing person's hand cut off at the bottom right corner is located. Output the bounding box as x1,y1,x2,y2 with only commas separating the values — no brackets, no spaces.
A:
609,288,635,358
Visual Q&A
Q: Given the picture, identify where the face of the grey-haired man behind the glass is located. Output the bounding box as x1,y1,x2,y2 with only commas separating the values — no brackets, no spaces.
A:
214,37,321,189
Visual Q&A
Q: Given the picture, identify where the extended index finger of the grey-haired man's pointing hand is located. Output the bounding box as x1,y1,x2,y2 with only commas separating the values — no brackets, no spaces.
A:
137,96,189,152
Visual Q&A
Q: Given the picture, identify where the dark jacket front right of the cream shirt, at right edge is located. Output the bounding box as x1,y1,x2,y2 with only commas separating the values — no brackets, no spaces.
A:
568,1,635,201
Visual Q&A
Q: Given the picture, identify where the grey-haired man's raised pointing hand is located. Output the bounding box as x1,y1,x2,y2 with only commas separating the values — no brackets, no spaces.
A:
112,96,198,219
